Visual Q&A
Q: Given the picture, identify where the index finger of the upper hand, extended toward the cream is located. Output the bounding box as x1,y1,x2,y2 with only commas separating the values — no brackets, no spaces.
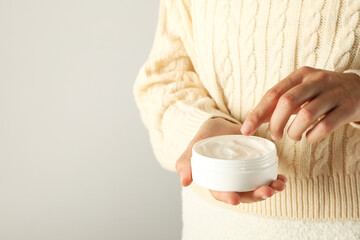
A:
241,67,314,136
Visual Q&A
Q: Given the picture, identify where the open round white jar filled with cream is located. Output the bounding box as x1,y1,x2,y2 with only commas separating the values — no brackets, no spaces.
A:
191,135,278,192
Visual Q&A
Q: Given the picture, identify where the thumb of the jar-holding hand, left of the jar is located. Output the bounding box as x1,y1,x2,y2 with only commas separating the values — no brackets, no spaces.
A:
176,147,192,187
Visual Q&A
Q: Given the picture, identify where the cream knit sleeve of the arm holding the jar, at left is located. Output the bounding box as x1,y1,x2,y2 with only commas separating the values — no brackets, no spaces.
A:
133,0,240,171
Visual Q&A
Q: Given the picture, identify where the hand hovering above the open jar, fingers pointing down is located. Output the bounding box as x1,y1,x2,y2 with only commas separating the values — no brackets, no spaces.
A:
241,66,360,143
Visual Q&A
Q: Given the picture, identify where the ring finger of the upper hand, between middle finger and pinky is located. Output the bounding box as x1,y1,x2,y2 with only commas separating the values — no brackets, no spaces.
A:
287,93,338,141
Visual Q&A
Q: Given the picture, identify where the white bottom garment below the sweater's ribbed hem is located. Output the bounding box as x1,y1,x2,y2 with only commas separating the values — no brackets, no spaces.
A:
182,187,360,240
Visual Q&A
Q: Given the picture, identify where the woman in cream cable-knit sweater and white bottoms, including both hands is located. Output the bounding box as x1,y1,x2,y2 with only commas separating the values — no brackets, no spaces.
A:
134,0,360,239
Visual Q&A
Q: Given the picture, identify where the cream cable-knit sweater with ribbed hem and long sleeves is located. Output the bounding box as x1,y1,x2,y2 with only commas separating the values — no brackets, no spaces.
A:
134,0,360,220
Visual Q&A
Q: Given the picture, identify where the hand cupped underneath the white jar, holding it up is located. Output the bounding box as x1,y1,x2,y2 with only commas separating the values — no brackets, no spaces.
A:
176,118,287,205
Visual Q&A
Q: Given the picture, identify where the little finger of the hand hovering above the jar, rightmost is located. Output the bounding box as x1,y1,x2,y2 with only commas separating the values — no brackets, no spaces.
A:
306,107,347,143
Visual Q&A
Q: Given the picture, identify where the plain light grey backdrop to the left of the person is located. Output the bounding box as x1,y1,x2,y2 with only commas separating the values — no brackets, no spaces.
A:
0,0,182,240
